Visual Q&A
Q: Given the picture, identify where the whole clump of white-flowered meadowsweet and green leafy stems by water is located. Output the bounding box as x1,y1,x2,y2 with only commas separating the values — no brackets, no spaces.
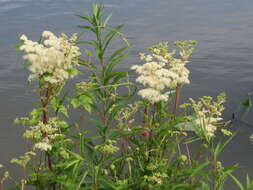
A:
0,4,252,190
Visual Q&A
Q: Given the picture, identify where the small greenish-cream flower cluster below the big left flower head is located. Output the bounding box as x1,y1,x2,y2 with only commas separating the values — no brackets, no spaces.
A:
24,118,66,151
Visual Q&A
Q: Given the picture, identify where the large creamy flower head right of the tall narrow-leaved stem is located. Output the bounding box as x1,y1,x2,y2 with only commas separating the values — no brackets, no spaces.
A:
131,42,193,104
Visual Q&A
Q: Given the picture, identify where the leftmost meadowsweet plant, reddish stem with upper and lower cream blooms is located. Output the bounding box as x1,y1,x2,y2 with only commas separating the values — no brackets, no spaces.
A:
11,31,81,189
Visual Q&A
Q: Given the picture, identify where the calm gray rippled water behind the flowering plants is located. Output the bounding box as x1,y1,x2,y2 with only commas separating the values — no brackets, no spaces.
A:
0,0,253,189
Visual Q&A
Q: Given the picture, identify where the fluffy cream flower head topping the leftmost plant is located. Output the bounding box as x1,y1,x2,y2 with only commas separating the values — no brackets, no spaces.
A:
20,31,81,84
